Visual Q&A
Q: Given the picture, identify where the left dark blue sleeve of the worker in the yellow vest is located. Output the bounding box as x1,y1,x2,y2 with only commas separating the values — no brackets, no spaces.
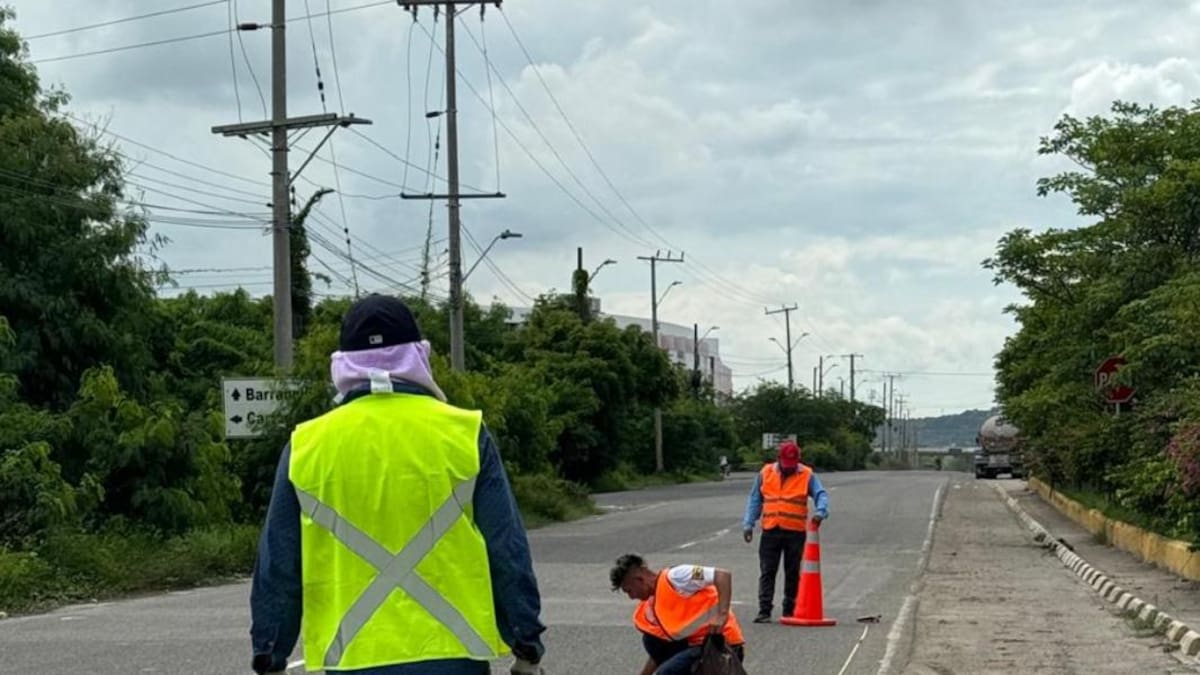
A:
250,443,301,671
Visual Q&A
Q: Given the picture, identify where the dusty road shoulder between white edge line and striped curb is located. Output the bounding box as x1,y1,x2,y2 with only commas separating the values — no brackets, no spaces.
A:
904,480,1196,675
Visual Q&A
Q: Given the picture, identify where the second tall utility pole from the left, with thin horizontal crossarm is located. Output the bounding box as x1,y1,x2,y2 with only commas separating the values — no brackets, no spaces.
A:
398,0,504,371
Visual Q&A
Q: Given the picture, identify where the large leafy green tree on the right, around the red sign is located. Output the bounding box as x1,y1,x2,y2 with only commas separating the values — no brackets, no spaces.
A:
984,102,1200,536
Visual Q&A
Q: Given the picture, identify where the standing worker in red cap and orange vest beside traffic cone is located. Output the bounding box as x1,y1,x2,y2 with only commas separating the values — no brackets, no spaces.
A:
742,441,829,623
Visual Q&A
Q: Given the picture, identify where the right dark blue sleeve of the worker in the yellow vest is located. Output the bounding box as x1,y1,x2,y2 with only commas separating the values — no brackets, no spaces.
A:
474,429,546,662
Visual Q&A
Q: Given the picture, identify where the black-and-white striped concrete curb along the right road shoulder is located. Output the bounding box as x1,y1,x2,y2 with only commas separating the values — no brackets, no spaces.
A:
992,485,1200,663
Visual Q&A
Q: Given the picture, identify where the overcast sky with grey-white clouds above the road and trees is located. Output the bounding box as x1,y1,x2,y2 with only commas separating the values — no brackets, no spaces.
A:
14,0,1200,416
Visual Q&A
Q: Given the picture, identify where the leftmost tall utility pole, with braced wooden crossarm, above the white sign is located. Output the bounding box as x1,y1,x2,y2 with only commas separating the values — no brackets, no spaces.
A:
212,0,371,369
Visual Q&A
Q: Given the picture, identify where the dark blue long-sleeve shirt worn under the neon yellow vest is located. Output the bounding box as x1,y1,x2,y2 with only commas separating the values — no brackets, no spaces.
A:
250,383,546,675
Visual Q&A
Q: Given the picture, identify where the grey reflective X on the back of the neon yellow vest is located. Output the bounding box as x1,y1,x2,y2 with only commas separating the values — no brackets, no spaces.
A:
296,478,494,668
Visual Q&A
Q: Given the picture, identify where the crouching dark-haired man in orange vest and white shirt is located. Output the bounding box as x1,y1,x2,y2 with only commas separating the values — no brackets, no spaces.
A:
608,554,745,675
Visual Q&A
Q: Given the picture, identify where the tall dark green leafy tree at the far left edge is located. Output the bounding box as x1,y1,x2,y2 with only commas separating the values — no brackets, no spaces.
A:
0,10,155,408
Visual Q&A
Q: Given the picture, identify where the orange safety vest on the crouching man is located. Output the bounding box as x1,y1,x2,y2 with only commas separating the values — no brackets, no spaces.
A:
634,572,745,646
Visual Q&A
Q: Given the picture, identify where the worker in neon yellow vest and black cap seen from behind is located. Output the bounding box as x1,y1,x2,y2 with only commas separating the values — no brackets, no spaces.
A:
250,295,546,675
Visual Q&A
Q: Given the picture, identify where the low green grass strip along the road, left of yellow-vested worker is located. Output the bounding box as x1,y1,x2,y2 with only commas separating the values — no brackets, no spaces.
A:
0,525,258,614
